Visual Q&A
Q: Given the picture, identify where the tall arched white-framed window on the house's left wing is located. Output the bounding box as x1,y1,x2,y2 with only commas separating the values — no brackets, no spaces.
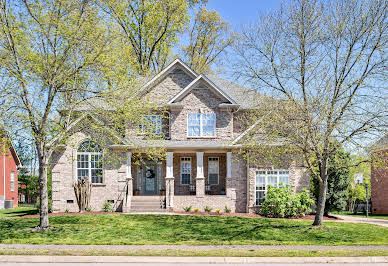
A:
77,140,103,183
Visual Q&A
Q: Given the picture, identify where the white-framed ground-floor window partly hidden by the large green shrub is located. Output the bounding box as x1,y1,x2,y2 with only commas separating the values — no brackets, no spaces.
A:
255,170,290,205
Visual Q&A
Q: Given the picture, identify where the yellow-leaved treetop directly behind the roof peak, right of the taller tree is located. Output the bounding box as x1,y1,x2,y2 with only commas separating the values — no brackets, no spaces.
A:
182,7,233,73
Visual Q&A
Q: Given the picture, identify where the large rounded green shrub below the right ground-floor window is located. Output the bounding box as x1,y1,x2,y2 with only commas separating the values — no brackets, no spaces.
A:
260,186,314,218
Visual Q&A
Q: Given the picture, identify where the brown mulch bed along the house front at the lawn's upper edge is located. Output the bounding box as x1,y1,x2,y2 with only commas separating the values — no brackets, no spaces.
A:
20,211,342,221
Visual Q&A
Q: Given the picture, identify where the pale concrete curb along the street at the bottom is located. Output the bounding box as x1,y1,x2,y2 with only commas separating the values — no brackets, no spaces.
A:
0,255,388,264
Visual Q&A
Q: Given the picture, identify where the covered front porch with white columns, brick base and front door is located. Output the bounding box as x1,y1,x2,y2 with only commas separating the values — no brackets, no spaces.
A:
123,151,236,212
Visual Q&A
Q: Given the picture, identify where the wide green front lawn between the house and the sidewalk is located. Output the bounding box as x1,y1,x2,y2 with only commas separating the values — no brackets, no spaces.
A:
0,208,388,245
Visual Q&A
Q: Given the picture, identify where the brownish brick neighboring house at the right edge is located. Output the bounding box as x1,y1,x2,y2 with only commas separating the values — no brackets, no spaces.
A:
371,135,388,214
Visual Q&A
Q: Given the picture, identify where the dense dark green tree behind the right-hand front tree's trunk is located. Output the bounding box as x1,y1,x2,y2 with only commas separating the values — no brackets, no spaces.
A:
311,144,352,216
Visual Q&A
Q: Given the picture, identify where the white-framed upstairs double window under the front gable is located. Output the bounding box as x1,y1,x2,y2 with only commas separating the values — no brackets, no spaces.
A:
187,113,216,137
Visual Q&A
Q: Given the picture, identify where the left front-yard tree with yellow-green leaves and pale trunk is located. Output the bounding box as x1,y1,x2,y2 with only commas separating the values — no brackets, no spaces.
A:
0,0,156,230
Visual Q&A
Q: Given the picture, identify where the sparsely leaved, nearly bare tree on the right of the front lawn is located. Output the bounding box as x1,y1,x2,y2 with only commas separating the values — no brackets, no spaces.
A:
233,0,388,225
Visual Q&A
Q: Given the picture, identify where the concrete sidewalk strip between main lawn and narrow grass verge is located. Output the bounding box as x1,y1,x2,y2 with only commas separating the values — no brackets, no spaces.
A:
0,244,388,250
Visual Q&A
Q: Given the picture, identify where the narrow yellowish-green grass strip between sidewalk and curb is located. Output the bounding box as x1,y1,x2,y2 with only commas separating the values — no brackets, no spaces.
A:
0,248,388,257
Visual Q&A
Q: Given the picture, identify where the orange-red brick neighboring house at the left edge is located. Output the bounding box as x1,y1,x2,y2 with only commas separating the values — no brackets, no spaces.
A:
0,132,20,209
